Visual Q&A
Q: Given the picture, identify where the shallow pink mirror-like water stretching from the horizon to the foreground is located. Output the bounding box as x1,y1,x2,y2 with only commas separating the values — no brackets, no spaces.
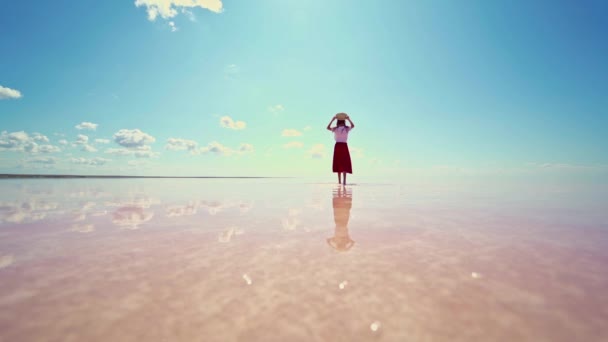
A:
0,179,608,341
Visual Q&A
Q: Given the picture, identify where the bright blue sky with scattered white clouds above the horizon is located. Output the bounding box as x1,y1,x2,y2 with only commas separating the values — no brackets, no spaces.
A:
0,0,608,181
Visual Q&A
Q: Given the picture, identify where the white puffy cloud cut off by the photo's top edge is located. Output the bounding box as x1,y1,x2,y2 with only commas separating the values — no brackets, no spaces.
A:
135,0,223,21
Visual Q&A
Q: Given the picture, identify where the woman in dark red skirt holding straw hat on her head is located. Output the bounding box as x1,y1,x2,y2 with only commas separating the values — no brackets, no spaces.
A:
327,113,355,185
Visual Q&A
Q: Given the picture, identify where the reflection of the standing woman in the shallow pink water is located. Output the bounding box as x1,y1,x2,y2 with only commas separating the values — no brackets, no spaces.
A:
327,185,355,252
